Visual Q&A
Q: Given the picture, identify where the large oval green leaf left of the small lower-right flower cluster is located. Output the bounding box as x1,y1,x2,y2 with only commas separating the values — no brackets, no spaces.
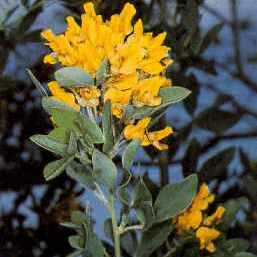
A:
154,174,198,222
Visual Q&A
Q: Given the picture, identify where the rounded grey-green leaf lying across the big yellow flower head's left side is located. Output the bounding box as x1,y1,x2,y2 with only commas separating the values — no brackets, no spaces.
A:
55,67,94,88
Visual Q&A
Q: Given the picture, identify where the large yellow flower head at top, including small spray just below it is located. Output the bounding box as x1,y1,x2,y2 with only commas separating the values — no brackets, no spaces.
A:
42,3,172,149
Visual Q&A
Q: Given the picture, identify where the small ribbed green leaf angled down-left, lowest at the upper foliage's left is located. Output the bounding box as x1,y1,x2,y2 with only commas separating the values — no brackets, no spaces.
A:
43,156,74,181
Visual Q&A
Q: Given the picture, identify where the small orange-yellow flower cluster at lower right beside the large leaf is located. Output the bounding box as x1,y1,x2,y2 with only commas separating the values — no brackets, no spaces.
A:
173,184,225,252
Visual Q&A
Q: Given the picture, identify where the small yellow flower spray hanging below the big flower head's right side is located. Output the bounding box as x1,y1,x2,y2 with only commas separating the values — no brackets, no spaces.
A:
124,117,173,150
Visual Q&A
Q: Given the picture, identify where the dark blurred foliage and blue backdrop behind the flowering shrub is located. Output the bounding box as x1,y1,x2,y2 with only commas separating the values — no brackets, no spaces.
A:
0,0,257,257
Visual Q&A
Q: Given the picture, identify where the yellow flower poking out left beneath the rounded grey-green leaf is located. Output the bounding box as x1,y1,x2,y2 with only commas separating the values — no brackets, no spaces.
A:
48,81,80,111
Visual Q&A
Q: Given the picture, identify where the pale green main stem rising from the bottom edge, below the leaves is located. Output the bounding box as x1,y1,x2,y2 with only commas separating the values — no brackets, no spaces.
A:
109,195,121,257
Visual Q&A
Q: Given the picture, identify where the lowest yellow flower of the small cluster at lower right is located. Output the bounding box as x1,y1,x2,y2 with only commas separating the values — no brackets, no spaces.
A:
196,227,221,253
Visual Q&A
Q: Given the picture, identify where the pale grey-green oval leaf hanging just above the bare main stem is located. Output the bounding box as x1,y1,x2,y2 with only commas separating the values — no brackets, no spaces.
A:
92,149,118,188
